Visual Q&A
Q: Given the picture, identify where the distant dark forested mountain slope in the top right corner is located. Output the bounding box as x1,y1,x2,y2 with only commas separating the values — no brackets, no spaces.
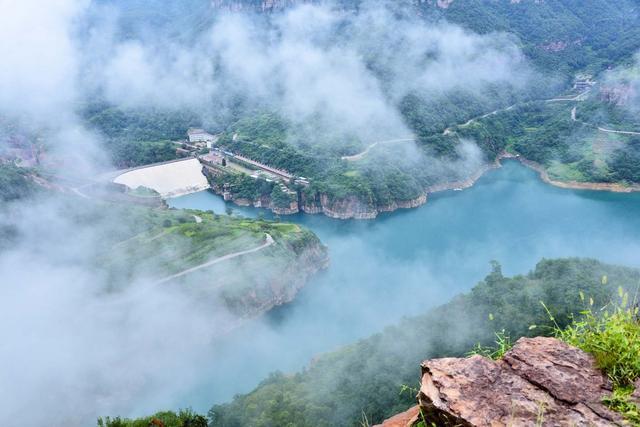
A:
418,0,640,74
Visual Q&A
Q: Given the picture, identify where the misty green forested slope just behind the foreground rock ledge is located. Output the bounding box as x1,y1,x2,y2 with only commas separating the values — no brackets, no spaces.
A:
209,259,640,427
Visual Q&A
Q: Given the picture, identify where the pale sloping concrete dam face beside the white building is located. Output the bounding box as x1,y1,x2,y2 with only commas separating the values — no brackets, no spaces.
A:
113,158,209,198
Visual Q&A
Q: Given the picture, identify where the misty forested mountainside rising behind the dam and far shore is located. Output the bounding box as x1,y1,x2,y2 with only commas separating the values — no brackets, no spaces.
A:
82,0,640,217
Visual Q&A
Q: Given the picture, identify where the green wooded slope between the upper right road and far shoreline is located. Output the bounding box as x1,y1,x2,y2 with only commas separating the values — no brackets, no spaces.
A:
449,95,640,183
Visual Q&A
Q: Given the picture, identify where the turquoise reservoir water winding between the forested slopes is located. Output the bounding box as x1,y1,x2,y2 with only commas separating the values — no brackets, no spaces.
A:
169,160,640,411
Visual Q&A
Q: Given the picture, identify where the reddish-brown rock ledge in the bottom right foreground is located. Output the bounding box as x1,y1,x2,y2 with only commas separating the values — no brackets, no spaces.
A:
382,337,624,427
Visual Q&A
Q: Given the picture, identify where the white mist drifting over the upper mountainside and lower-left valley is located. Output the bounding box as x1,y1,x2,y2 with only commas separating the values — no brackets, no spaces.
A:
0,0,531,426
